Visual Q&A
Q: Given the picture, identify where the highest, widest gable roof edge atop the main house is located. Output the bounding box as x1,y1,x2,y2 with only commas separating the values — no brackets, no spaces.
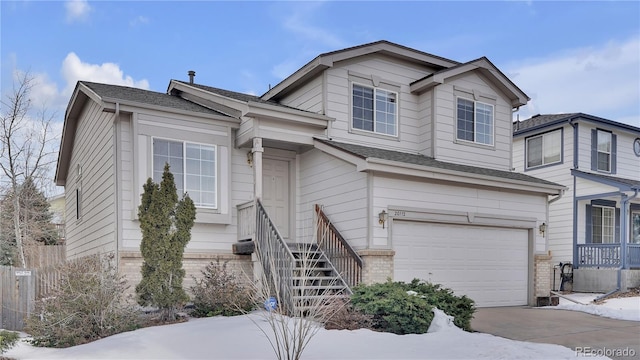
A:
261,40,460,100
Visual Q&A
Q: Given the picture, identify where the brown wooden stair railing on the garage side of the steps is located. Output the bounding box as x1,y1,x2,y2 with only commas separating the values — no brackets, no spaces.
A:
316,204,362,287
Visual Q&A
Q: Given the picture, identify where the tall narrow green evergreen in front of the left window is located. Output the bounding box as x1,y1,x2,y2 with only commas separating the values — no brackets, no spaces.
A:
136,164,196,321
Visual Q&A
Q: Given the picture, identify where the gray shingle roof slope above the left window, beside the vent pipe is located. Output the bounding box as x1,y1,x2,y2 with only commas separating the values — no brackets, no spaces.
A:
80,81,227,116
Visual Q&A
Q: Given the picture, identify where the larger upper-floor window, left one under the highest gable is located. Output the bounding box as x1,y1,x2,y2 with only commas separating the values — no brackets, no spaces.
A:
352,84,398,136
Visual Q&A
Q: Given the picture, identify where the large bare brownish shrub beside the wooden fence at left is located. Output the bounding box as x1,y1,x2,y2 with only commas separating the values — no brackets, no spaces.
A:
25,256,138,347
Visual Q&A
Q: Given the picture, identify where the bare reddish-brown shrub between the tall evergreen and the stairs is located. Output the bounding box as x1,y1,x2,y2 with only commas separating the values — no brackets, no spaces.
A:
191,260,254,317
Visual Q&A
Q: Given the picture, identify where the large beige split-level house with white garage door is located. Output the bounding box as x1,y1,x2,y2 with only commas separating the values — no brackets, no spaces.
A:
56,41,564,306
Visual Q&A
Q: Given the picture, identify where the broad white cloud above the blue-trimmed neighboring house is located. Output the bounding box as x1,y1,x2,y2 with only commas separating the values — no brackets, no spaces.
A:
505,37,640,126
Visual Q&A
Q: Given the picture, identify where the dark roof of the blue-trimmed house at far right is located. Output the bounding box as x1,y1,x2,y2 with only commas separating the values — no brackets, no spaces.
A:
513,113,640,136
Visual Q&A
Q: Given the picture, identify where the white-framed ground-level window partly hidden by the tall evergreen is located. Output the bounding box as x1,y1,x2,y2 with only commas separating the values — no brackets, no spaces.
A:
153,138,218,209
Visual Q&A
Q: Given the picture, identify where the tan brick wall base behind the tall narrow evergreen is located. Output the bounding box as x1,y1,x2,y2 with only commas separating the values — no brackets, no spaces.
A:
119,251,253,294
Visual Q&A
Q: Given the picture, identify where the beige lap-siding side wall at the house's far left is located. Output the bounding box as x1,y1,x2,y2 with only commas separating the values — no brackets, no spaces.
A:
65,101,116,258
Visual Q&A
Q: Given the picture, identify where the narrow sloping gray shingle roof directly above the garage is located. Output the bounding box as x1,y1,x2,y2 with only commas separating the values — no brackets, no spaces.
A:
317,139,562,186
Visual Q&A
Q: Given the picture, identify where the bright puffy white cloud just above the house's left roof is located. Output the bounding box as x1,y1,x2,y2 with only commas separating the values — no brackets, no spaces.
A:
61,52,149,96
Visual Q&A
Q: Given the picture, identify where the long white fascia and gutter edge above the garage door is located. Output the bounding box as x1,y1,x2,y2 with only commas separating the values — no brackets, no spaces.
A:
359,158,565,195
